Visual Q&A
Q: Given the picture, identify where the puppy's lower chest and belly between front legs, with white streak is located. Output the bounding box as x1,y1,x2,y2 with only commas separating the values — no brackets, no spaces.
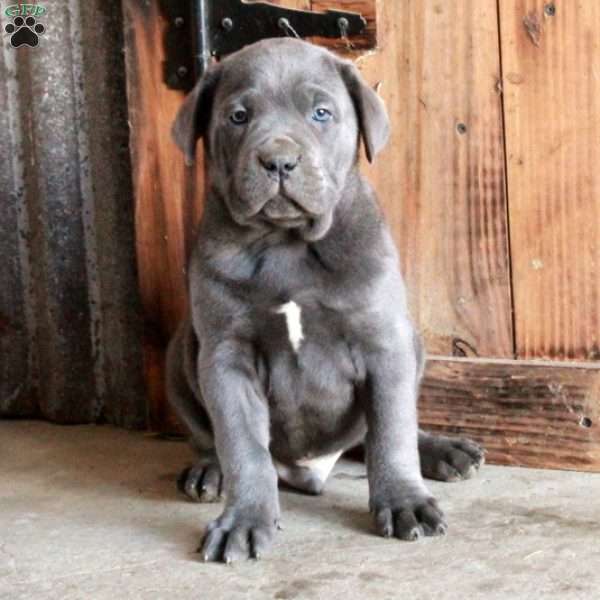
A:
259,300,364,460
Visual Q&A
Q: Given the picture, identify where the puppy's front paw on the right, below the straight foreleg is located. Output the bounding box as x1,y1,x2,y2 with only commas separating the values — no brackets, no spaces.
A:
371,492,448,542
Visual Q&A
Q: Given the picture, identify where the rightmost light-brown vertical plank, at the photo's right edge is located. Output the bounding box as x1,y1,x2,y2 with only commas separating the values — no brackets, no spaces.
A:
498,0,600,360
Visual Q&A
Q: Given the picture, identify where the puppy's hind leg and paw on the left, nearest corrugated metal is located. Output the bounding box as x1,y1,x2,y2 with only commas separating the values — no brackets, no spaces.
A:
166,320,223,502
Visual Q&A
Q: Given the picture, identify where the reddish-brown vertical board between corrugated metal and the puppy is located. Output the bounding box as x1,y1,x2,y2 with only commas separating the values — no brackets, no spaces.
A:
123,0,203,429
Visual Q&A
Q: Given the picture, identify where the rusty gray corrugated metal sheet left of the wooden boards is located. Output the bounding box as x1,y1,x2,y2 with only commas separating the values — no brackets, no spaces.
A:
0,0,146,427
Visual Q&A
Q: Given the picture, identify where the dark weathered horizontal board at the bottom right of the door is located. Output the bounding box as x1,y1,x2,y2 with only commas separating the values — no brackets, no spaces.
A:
419,357,600,471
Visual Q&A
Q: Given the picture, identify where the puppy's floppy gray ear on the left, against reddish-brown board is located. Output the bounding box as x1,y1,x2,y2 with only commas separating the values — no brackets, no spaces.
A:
171,65,220,166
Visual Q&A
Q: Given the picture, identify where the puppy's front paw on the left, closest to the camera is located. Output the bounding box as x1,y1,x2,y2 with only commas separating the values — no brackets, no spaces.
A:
198,507,278,563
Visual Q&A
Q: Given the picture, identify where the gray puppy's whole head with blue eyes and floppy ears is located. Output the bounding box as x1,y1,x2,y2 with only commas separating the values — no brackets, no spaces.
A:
173,38,389,240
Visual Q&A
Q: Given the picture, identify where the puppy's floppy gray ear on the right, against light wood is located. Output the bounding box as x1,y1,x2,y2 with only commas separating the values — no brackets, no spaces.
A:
340,62,390,162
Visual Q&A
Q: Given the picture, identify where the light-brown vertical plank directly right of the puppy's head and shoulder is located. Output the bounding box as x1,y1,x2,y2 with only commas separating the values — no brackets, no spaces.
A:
357,0,513,357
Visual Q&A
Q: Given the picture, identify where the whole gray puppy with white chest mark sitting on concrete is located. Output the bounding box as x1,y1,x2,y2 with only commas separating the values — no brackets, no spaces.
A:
167,39,483,562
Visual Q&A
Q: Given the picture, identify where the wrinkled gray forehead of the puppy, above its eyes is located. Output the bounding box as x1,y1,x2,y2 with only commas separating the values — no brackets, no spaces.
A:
217,40,345,101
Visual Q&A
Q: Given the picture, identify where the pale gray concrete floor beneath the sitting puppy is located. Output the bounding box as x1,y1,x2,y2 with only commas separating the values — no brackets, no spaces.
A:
0,421,600,600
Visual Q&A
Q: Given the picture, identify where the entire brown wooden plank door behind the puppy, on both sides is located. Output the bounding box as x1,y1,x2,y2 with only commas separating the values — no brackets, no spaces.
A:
124,0,600,470
